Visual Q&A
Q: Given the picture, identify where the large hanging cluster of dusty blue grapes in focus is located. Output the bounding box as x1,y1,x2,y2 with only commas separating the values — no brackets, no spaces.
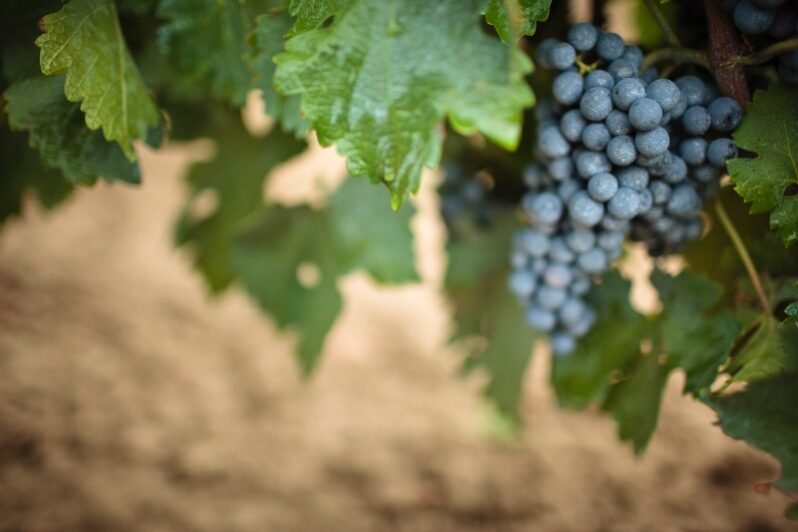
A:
509,23,742,355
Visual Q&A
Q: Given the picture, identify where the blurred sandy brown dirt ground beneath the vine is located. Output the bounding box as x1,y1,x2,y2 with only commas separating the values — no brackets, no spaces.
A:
0,141,790,532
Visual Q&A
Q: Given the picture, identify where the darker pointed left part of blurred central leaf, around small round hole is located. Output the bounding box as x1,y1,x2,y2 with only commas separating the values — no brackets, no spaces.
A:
232,206,341,374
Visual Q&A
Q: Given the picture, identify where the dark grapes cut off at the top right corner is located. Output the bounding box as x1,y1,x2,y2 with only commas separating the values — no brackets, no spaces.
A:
723,0,798,84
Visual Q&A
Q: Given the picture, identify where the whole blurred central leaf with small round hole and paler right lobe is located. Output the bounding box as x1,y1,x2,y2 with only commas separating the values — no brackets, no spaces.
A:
232,179,417,374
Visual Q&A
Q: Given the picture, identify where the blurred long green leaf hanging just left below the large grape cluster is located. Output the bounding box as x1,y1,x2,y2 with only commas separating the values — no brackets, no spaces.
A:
444,213,537,422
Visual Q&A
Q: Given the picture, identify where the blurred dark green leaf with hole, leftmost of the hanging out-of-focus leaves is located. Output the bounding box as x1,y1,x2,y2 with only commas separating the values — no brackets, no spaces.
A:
175,108,305,292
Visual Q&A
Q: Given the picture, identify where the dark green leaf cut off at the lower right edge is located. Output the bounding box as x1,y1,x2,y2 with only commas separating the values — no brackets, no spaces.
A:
703,373,798,492
